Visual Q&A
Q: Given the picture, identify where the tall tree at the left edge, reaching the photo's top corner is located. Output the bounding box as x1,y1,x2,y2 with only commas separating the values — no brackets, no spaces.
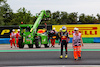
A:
0,0,12,25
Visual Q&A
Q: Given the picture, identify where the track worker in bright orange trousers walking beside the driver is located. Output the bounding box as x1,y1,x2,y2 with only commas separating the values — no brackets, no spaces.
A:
72,28,83,60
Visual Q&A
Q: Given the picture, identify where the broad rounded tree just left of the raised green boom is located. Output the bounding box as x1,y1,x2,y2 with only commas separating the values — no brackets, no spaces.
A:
11,7,35,25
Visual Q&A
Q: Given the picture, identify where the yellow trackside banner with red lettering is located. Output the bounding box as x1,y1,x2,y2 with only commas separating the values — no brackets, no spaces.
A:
52,24,100,37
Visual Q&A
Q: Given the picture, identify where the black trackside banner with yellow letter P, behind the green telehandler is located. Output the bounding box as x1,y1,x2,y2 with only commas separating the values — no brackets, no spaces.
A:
0,25,52,38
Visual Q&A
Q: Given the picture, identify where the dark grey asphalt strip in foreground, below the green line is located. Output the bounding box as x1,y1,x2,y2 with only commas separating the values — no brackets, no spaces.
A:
0,51,100,66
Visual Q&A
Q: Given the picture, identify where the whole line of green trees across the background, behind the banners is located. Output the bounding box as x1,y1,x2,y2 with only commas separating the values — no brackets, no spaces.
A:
0,0,100,25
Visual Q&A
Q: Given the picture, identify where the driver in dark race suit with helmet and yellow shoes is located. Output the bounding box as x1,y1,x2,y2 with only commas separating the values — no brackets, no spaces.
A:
60,26,69,59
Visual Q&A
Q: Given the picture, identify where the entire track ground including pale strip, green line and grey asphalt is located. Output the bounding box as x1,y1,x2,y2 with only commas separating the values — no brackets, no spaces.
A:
0,43,100,67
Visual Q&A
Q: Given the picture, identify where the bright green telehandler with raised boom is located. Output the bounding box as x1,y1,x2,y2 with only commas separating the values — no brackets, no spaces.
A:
18,10,49,48
